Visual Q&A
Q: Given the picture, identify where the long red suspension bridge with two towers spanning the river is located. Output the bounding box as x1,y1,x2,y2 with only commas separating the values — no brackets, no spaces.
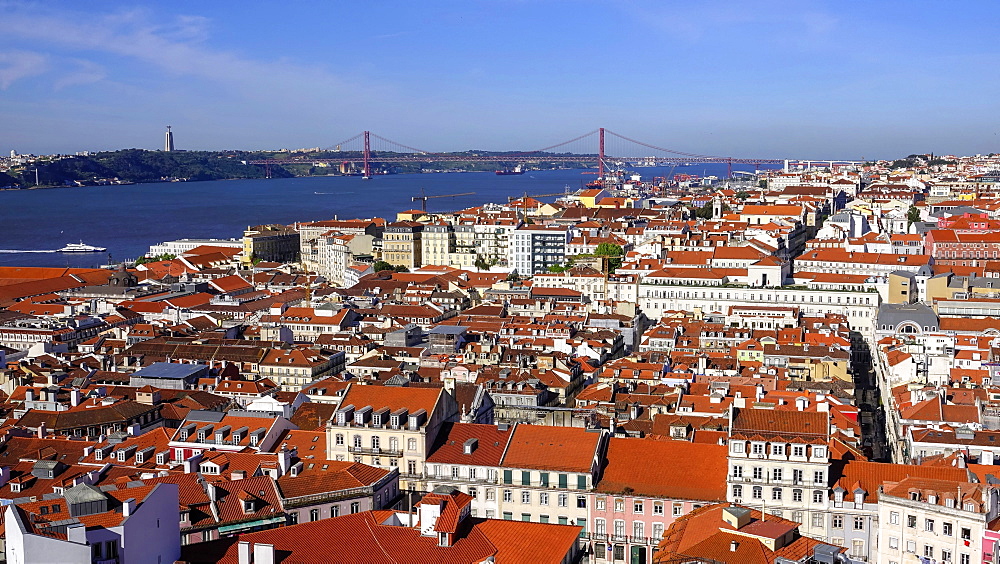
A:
247,127,859,178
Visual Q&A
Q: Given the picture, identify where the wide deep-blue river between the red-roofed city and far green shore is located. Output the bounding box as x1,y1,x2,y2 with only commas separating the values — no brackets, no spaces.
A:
0,165,768,268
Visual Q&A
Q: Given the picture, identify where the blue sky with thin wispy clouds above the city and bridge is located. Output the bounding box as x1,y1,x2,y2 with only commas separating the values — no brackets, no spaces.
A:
0,0,1000,158
